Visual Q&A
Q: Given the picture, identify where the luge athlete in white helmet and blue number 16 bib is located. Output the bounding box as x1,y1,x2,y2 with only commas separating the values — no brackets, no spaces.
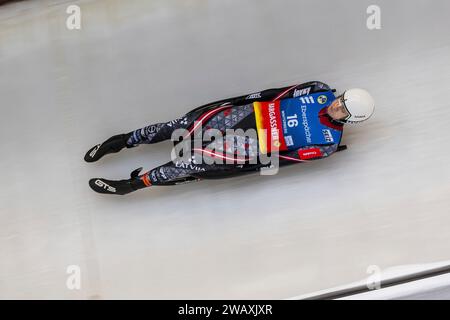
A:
84,81,375,195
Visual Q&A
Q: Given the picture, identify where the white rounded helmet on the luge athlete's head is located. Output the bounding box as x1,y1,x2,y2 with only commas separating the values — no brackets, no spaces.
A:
341,88,375,123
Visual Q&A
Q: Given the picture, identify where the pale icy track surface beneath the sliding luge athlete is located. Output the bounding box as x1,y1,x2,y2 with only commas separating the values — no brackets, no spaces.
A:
0,0,450,299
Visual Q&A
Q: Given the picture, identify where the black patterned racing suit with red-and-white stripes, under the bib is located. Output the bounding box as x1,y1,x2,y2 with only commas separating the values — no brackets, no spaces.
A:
126,81,345,186
